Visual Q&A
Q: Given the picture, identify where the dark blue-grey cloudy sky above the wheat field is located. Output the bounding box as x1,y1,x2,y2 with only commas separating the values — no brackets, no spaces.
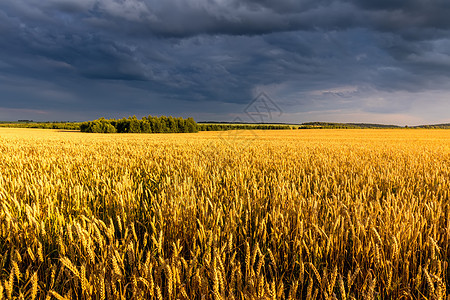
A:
0,0,450,125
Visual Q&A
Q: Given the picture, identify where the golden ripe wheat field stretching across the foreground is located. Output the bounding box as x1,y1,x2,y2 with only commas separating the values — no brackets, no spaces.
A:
0,128,450,299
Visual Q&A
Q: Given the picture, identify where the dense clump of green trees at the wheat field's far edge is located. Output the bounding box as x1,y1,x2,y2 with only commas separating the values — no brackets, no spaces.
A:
80,116,198,133
